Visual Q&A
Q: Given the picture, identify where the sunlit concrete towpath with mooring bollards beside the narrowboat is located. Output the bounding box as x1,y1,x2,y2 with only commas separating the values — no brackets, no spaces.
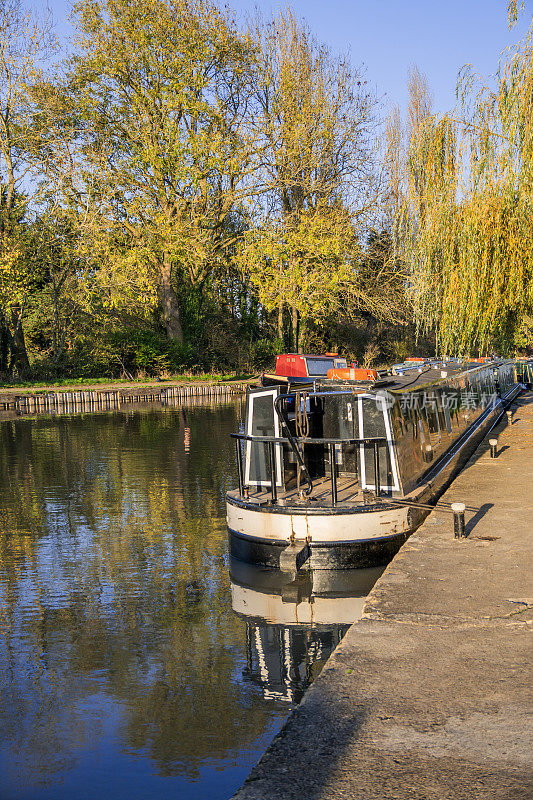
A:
235,392,533,800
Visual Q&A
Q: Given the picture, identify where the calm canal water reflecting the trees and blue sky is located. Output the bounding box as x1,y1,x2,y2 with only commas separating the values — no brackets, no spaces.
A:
0,404,377,800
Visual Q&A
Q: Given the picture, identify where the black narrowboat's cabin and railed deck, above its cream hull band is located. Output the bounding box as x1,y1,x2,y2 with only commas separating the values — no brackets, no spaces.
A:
237,355,516,504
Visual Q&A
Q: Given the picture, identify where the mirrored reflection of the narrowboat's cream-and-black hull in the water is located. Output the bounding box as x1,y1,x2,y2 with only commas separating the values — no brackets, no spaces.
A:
230,559,384,703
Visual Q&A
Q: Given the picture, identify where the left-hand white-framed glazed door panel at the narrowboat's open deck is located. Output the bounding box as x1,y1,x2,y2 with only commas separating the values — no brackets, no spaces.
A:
245,387,282,486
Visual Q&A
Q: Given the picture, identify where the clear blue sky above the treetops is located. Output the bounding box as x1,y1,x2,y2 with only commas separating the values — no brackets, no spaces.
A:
47,0,533,112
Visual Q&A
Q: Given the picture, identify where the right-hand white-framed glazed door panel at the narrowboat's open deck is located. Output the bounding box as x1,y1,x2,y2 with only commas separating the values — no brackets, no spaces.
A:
357,394,400,492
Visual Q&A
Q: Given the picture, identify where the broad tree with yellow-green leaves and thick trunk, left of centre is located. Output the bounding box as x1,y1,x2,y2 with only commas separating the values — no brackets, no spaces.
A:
30,0,253,340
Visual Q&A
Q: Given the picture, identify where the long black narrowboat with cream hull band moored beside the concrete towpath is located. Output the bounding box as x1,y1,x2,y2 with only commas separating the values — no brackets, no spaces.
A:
226,355,533,571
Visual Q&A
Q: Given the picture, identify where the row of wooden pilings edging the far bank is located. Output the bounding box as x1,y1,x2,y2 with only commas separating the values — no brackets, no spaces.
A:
0,382,247,414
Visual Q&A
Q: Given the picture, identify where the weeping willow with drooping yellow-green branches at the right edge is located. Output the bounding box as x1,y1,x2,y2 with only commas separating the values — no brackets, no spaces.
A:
390,31,533,355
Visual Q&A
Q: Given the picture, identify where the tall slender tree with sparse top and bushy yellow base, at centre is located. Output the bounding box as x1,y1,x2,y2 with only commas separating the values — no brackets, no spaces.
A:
241,11,388,349
